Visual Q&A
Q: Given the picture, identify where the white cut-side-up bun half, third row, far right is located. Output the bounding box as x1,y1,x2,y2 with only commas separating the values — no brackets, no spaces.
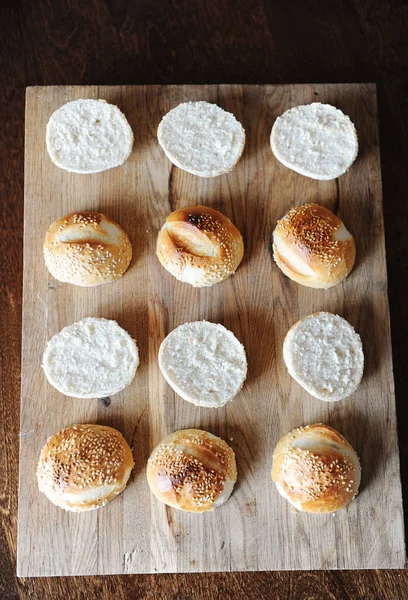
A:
283,312,364,402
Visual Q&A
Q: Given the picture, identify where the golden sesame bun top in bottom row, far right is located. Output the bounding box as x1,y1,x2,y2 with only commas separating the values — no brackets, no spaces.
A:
272,423,361,513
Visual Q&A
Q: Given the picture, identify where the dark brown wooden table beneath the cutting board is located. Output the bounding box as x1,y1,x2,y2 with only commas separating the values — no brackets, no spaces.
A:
0,0,408,600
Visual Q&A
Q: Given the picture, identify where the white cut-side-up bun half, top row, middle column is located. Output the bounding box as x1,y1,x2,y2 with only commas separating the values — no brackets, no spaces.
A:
157,102,245,177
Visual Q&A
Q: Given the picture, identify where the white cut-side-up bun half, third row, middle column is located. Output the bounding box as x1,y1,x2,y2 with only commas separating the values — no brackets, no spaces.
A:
159,321,247,408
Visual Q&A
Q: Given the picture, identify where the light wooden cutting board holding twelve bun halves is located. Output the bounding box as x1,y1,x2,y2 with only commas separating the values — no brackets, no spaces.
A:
17,84,405,576
